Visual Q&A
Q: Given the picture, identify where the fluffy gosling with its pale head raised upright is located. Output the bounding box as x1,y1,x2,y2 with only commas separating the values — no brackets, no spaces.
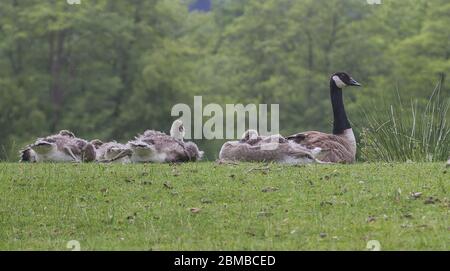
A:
127,120,203,163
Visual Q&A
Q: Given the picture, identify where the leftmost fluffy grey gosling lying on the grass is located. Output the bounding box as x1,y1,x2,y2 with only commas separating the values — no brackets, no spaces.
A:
21,130,96,162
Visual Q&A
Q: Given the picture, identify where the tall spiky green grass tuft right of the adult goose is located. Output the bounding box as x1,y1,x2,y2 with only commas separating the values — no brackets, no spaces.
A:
360,84,450,162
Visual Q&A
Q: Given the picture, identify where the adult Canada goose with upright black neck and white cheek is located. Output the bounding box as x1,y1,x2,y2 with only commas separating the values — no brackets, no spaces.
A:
287,72,361,163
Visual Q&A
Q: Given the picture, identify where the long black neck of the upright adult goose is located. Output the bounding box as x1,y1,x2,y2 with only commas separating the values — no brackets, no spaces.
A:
330,80,351,135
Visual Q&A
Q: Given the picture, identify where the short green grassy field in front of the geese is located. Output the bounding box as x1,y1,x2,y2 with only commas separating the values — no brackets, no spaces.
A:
0,162,450,250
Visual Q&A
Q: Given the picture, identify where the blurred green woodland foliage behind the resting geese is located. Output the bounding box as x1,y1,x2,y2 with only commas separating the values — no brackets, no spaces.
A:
0,0,450,160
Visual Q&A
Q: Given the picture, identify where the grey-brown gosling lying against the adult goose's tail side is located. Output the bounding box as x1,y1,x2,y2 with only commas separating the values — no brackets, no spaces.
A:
219,130,321,164
